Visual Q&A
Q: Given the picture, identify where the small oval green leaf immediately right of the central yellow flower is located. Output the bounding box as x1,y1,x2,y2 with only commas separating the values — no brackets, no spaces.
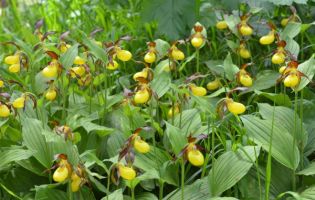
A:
151,72,171,98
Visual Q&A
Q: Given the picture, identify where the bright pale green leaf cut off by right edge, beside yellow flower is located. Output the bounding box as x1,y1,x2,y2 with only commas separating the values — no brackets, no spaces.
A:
294,54,315,92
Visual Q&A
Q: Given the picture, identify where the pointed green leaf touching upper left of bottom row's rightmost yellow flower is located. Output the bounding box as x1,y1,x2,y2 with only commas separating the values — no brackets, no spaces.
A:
165,122,187,155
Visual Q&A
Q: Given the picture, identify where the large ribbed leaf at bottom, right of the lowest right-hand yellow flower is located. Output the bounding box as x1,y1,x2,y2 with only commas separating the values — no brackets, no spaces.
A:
209,146,260,197
